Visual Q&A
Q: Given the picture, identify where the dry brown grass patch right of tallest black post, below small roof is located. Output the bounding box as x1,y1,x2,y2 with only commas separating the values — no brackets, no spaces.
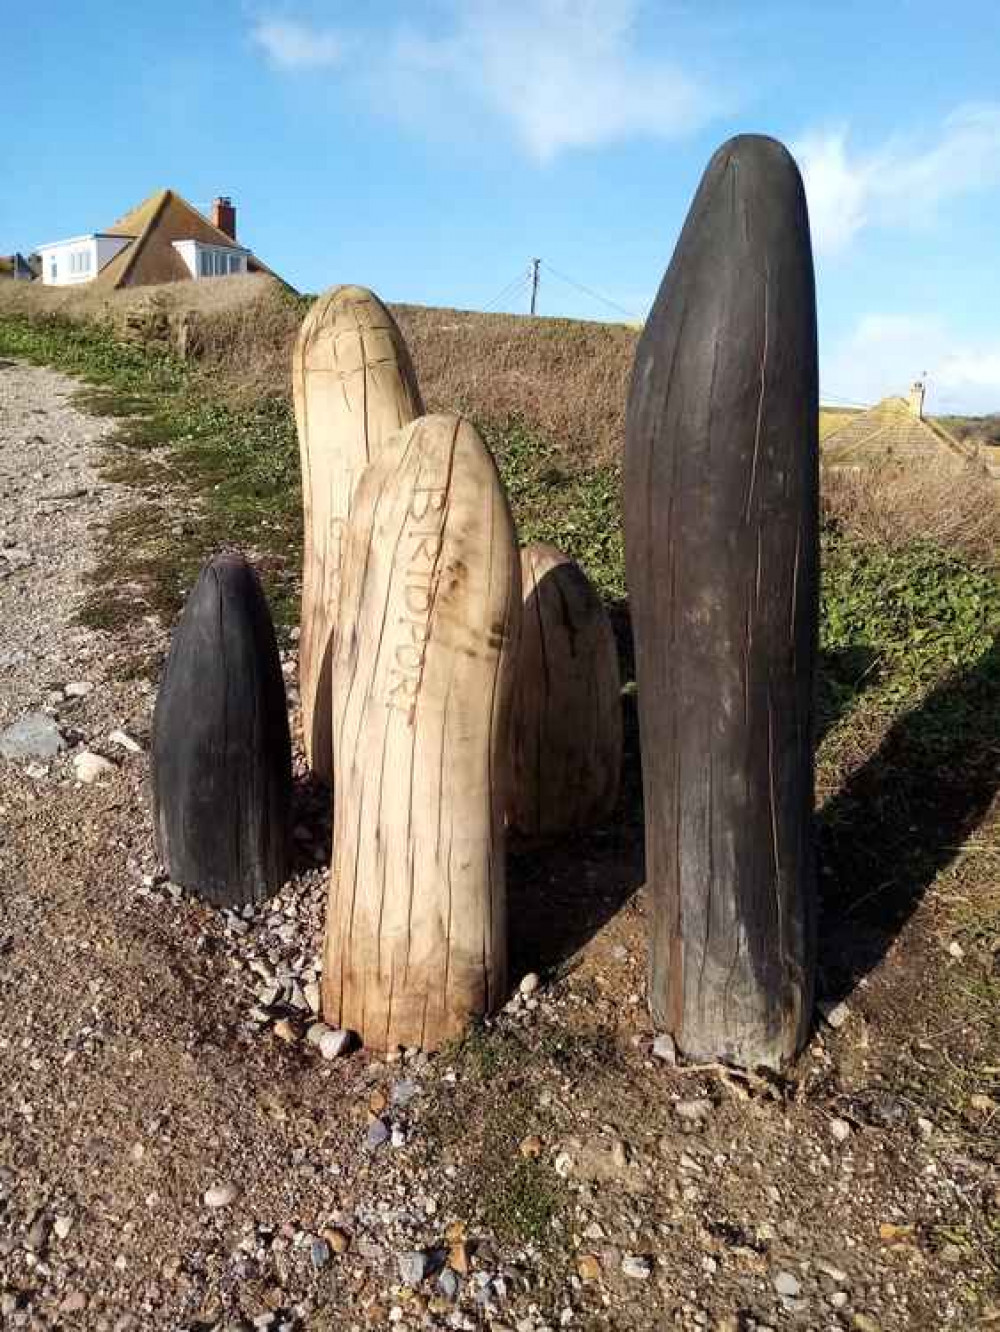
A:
820,466,1000,565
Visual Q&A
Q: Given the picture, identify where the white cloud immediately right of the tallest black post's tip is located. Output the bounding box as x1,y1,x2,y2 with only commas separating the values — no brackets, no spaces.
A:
795,103,1000,253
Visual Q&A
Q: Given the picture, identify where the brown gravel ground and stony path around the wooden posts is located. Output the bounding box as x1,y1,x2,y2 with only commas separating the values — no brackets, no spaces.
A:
0,362,1000,1332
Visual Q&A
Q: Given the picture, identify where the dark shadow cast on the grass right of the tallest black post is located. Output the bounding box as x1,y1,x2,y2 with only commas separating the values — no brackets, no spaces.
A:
819,646,1000,999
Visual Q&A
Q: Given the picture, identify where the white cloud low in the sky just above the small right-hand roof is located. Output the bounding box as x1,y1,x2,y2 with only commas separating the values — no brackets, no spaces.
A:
820,314,1000,414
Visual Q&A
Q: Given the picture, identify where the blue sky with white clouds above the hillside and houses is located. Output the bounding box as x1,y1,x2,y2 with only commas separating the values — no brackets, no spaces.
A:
0,0,1000,412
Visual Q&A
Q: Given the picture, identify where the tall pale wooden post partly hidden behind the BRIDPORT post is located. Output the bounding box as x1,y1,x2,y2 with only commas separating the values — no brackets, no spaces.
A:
292,286,423,781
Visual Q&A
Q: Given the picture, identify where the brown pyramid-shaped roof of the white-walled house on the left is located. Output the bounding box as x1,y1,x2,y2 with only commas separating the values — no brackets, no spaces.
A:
82,189,284,290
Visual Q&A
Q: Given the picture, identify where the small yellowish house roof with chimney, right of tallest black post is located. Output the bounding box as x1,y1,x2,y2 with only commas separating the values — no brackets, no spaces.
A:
820,380,977,472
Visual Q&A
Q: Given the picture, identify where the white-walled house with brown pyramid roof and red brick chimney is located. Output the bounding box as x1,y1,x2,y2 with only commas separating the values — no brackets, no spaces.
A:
39,189,284,290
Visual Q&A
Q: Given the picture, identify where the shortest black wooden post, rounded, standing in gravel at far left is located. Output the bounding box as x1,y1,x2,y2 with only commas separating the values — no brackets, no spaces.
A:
152,555,292,906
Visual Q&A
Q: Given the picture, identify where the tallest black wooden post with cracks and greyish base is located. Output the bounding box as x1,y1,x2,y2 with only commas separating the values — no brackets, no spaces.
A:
625,136,819,1066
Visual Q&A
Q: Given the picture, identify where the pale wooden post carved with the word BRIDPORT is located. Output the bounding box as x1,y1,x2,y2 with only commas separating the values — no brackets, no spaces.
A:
322,416,521,1050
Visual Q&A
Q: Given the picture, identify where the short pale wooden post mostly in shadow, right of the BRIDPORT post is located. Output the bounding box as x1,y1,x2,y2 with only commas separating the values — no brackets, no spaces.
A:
510,542,622,836
